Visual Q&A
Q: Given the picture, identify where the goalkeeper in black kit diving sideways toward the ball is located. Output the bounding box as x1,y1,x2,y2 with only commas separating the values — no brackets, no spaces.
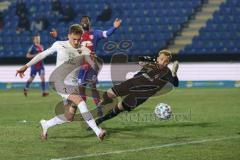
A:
96,50,179,125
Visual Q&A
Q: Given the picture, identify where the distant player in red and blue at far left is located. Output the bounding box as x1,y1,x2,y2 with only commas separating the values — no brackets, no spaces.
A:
23,34,48,97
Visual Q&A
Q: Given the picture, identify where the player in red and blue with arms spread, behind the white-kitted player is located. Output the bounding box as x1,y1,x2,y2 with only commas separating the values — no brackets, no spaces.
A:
50,16,122,111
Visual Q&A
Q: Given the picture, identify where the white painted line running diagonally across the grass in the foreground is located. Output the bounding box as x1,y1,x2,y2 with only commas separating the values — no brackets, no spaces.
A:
51,136,240,160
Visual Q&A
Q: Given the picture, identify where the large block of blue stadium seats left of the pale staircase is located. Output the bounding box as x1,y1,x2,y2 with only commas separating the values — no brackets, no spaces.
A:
0,0,204,56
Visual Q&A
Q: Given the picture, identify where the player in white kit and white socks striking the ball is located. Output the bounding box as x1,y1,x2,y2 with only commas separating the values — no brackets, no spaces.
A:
16,24,106,140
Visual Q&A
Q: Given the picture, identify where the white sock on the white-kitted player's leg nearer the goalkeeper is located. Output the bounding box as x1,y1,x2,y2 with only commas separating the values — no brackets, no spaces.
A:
78,101,101,136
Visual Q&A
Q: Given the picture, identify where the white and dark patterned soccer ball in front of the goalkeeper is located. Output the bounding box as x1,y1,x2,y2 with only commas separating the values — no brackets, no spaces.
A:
154,103,172,120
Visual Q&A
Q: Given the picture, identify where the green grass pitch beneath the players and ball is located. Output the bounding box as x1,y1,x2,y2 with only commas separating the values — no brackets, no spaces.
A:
0,88,240,160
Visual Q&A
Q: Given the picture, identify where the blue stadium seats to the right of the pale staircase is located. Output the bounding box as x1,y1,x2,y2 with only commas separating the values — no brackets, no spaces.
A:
184,0,240,54
